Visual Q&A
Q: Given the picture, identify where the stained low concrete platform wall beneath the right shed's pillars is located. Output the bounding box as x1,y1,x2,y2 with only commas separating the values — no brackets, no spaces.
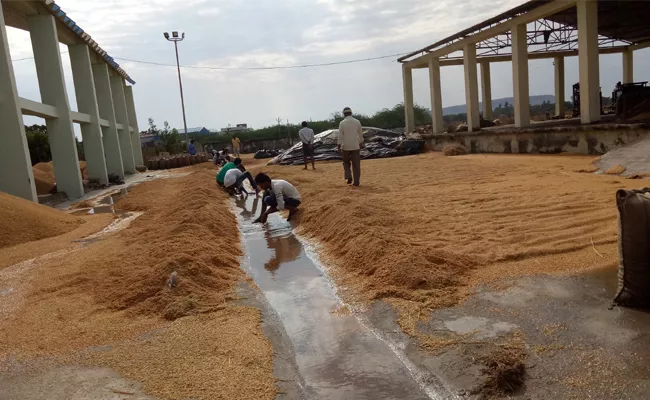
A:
423,125,650,155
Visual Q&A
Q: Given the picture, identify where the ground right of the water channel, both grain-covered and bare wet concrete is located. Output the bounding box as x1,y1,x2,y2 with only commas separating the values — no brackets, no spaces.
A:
251,153,650,399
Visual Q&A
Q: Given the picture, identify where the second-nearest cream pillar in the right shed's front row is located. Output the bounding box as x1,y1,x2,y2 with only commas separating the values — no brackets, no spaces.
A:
512,24,530,127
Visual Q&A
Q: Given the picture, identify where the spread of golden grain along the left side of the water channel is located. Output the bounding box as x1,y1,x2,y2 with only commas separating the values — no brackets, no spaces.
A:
0,165,276,399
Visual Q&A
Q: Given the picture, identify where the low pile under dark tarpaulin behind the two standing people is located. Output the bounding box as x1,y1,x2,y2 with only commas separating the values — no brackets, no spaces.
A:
269,128,425,165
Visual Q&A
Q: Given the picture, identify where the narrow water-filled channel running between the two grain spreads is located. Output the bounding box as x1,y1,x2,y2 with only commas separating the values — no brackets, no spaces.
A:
234,196,443,400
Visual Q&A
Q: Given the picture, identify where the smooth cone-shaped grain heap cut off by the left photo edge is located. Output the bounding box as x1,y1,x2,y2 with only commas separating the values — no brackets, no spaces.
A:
0,192,83,248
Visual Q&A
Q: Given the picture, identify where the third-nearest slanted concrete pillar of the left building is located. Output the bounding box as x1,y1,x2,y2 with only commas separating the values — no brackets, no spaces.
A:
68,44,108,185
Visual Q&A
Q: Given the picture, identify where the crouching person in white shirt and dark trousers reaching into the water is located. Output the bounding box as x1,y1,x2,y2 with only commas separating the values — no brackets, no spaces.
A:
254,172,300,223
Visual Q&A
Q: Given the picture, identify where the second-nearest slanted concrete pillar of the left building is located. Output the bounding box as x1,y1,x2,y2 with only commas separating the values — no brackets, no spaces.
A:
27,14,84,198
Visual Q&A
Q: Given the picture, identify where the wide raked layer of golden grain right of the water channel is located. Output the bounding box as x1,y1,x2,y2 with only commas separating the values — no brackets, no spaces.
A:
263,153,638,324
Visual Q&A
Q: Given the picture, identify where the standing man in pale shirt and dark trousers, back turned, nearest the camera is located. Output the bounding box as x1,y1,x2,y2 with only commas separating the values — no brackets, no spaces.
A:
338,107,363,186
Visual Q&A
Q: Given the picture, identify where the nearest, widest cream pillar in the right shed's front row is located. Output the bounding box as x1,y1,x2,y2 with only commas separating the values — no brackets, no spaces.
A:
576,0,600,124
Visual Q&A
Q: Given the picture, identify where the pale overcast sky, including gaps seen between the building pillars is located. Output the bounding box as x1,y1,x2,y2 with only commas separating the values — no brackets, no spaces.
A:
8,0,650,130
